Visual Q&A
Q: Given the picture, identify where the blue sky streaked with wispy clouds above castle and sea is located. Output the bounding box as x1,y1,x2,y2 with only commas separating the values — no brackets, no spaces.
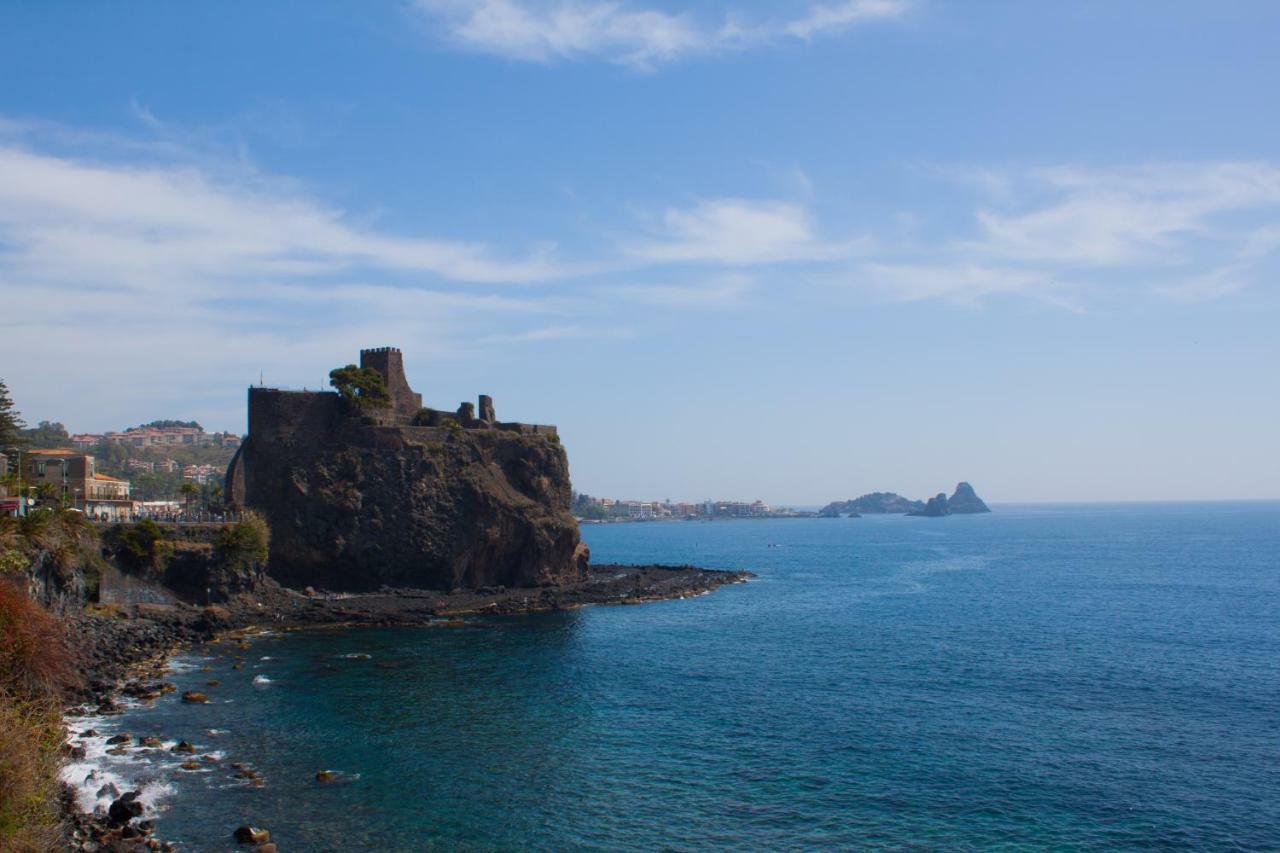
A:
0,0,1280,503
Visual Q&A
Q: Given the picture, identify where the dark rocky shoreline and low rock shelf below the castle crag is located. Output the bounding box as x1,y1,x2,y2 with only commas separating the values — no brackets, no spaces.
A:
63,565,753,853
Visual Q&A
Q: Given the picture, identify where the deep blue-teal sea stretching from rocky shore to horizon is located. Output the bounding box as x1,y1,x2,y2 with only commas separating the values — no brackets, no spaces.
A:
92,503,1280,850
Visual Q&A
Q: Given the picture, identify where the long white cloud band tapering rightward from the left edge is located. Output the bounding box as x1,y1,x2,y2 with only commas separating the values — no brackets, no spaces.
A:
0,146,567,287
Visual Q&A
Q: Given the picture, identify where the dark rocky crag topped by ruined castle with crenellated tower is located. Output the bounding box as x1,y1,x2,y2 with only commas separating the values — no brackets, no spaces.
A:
225,347,588,590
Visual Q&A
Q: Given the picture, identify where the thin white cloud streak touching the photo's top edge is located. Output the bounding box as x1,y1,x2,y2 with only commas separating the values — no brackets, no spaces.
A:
415,0,911,69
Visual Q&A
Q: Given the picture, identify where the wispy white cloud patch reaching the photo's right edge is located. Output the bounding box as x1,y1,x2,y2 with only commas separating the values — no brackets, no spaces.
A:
859,161,1280,306
